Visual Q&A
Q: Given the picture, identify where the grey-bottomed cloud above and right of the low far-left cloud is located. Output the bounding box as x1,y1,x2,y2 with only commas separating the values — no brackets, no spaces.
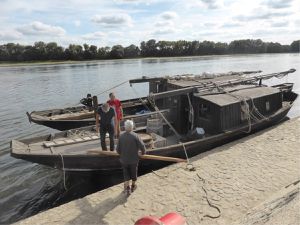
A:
92,14,132,27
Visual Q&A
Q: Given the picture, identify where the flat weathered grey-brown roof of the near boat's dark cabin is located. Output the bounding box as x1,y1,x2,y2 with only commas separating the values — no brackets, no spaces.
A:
194,85,280,106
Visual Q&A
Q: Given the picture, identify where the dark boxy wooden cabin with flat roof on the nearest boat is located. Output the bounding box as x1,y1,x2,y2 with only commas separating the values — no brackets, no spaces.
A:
193,85,282,134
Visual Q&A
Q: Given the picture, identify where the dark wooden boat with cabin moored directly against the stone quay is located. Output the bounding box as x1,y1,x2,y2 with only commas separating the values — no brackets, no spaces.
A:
11,70,298,172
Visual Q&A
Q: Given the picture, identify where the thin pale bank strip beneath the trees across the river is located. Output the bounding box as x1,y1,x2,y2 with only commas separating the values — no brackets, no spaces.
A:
0,53,297,67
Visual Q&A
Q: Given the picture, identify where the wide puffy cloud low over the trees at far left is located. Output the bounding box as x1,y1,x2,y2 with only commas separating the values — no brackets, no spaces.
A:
17,21,66,36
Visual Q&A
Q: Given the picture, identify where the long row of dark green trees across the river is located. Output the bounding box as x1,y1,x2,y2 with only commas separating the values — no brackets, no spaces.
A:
0,39,300,62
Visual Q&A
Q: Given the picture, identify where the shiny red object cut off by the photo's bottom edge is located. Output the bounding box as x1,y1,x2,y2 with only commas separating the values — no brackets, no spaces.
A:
134,212,186,225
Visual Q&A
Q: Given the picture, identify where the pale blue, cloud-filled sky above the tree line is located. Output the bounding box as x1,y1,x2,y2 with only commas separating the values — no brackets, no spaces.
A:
0,0,300,46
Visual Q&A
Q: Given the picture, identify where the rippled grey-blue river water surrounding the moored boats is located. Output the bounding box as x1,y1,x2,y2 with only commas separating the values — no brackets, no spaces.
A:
0,53,300,224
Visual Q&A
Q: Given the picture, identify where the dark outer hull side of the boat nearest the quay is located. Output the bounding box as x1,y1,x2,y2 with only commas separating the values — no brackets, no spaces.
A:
11,98,297,173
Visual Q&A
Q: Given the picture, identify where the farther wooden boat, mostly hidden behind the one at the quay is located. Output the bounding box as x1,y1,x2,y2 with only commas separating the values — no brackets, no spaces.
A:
27,70,261,130
